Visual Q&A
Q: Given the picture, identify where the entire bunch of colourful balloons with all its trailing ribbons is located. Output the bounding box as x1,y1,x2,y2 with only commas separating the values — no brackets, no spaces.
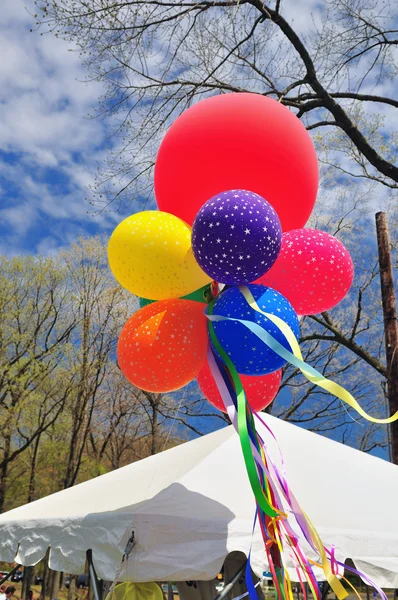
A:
109,94,398,599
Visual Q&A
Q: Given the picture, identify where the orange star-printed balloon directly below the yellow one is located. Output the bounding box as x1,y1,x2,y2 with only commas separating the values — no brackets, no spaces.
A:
117,299,208,393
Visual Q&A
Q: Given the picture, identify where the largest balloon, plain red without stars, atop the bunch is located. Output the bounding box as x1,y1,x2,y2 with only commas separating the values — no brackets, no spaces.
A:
155,93,318,231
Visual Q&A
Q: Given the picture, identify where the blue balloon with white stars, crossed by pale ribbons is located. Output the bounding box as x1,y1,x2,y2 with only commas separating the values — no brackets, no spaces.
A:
213,284,300,375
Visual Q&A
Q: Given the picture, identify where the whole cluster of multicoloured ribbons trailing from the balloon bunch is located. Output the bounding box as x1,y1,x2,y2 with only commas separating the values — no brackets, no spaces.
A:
208,286,390,600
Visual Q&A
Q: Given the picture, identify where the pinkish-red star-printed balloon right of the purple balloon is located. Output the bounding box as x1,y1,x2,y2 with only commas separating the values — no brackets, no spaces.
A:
255,229,354,315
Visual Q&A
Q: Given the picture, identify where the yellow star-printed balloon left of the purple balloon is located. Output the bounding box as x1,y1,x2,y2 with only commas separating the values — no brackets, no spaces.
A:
108,210,211,300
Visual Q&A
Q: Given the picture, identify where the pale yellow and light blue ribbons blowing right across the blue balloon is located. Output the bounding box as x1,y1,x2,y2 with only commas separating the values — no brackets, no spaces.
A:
207,285,398,424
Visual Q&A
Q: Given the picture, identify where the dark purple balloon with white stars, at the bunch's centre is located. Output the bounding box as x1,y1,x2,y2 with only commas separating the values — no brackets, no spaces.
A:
192,190,282,285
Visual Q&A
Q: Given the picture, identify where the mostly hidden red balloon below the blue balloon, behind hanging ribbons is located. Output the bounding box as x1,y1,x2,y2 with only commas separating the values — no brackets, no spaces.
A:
197,362,282,412
